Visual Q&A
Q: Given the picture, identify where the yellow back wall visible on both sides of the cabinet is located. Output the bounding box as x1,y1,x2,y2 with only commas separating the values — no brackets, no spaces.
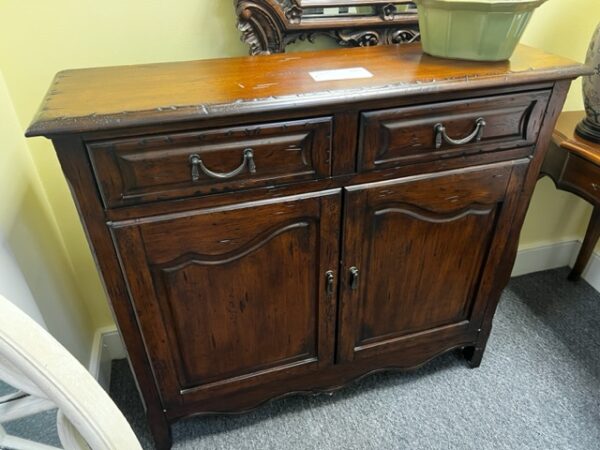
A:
0,0,600,338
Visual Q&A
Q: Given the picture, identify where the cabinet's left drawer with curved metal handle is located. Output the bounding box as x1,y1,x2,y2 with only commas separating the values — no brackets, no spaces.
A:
88,117,332,208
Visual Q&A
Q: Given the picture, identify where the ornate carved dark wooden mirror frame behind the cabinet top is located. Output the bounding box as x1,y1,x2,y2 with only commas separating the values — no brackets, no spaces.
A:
234,0,420,55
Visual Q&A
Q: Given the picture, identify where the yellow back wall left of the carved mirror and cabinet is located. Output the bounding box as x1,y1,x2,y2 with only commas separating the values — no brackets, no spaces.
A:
0,0,246,328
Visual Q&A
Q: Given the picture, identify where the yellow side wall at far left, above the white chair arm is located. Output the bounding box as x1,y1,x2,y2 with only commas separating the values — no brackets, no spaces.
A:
0,72,93,365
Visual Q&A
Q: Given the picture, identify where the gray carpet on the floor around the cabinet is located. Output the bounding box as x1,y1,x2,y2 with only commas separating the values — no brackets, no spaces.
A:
1,269,600,450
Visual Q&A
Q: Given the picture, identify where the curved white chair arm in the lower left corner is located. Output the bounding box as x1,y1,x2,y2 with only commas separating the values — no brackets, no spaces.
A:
0,295,141,450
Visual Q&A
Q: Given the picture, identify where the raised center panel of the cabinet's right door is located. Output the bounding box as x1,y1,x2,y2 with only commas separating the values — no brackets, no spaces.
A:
356,203,497,349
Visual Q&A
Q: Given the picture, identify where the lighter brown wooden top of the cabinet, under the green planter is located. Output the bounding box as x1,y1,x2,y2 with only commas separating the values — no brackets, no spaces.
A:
27,44,588,136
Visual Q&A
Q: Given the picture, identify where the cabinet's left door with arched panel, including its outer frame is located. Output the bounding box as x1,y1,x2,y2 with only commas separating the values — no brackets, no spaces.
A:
112,190,340,405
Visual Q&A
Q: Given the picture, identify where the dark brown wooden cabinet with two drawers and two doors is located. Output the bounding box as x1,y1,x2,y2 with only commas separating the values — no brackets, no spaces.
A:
28,44,585,449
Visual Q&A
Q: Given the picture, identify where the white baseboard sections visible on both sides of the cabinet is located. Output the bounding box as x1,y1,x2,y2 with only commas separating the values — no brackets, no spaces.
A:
89,240,600,384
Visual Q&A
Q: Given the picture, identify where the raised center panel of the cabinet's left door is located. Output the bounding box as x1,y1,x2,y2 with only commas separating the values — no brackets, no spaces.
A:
151,218,318,389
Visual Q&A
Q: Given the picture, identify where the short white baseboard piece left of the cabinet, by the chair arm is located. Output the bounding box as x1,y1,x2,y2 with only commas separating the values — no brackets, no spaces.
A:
89,326,127,392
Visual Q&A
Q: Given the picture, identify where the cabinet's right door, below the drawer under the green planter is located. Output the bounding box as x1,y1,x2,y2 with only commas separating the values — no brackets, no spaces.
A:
338,163,512,366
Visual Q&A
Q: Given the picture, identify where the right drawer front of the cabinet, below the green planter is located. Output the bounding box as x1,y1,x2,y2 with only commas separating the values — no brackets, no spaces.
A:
358,91,550,170
